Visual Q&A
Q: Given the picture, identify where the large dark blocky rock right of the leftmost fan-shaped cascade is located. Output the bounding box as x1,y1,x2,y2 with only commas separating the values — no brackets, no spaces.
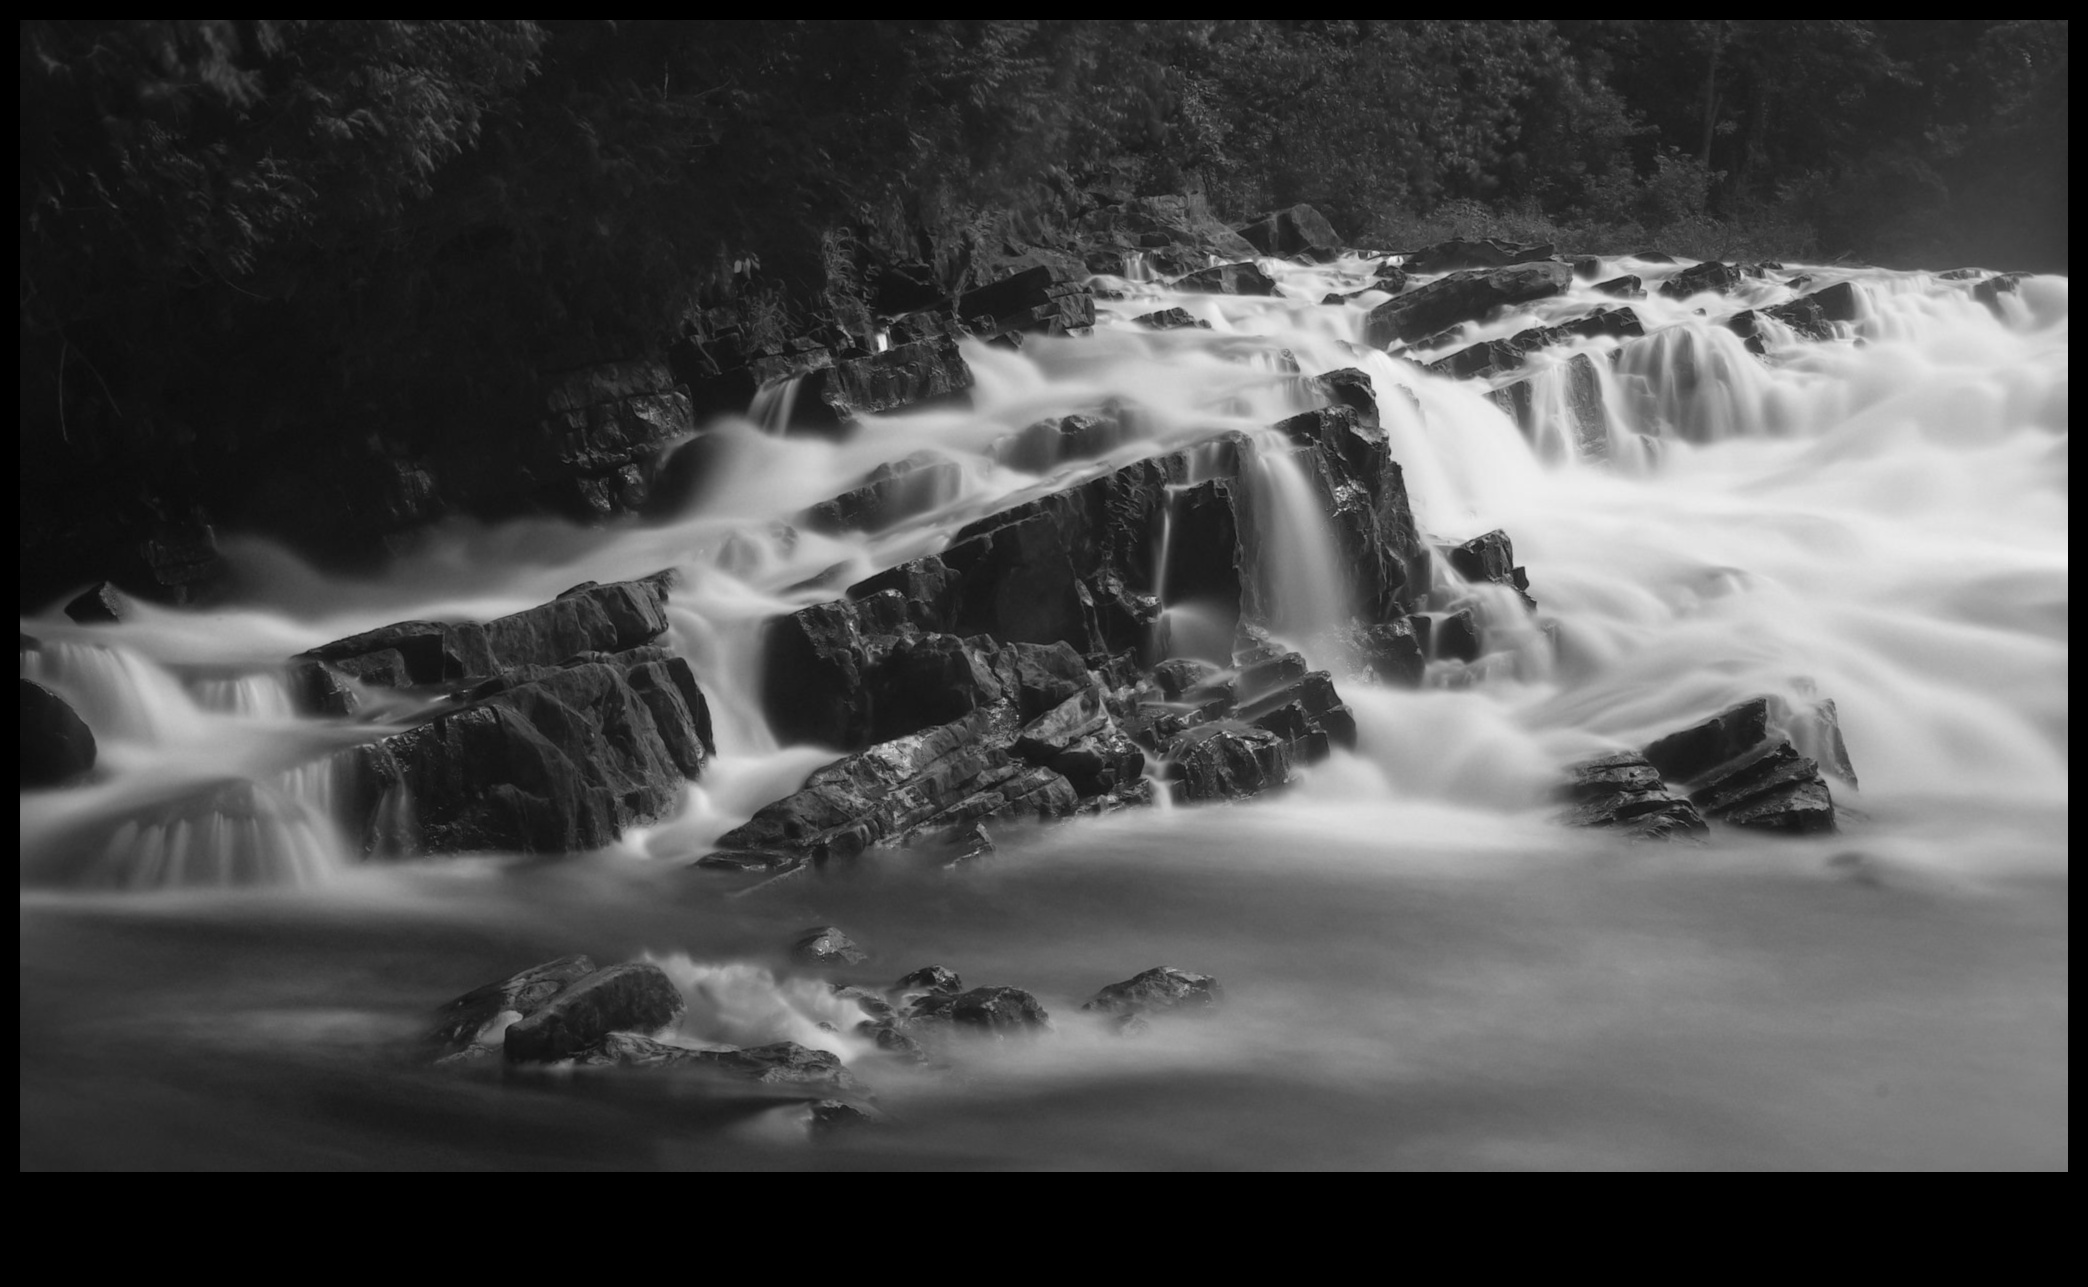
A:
342,648,710,852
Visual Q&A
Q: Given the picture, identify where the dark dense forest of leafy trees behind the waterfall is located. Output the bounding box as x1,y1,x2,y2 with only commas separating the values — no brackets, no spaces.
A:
21,19,2067,601
